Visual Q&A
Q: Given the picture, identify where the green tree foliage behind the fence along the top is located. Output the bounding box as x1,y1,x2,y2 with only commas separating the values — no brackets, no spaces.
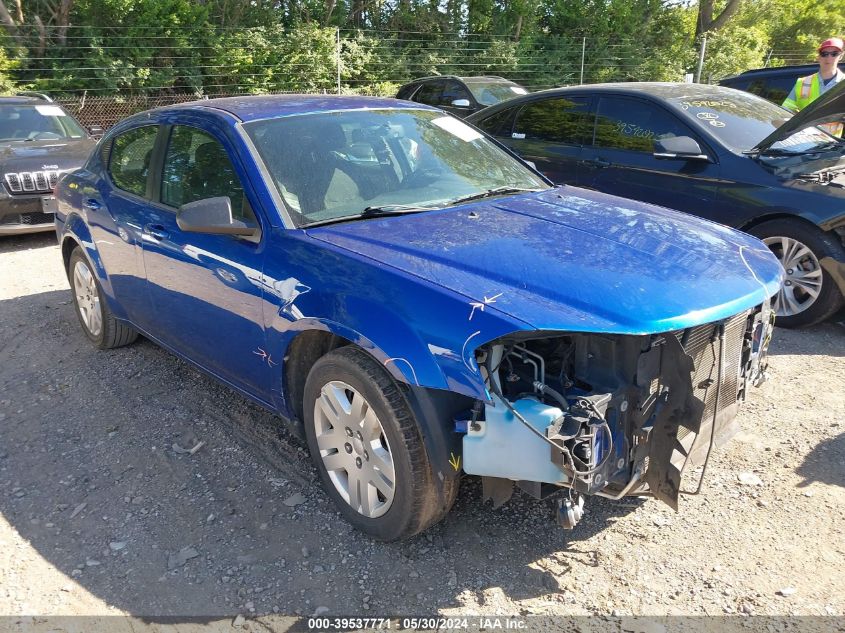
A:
0,0,832,95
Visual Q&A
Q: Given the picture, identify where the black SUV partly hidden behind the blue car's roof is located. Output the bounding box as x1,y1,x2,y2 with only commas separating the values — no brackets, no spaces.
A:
396,75,528,118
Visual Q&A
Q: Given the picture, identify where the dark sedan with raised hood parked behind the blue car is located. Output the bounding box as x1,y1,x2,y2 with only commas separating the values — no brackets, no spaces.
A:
468,83,845,327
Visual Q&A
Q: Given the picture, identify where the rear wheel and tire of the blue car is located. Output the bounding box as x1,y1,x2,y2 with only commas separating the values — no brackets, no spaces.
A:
67,246,138,349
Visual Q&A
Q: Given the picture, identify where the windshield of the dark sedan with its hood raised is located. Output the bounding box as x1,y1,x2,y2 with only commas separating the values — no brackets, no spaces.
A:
669,92,833,153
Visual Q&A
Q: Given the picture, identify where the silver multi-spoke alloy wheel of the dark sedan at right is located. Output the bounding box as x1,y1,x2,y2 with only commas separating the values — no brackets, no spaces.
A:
763,236,822,316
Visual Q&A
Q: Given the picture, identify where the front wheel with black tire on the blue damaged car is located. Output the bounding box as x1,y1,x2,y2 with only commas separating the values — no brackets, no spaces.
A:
304,346,456,541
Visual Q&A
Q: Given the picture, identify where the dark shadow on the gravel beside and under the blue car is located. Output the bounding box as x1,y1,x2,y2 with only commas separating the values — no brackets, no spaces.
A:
0,286,639,620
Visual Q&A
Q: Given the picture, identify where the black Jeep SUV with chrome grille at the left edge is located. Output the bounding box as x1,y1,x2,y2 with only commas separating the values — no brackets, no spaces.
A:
0,94,95,236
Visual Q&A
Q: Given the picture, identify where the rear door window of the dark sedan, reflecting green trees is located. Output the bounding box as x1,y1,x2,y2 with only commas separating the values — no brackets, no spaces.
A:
512,97,593,145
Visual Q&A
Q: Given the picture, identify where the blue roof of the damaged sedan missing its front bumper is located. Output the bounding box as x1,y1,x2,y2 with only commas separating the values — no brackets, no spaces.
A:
150,94,436,122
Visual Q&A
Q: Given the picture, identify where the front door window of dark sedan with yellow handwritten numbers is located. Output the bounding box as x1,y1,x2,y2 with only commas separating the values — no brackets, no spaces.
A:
594,97,700,154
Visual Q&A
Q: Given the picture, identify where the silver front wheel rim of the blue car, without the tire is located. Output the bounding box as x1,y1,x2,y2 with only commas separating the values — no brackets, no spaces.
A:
314,381,396,519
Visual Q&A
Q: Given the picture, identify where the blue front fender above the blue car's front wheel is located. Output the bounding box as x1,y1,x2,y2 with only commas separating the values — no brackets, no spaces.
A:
261,231,533,400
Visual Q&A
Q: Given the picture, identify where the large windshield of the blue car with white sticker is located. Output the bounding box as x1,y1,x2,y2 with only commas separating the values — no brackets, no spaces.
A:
244,110,548,226
